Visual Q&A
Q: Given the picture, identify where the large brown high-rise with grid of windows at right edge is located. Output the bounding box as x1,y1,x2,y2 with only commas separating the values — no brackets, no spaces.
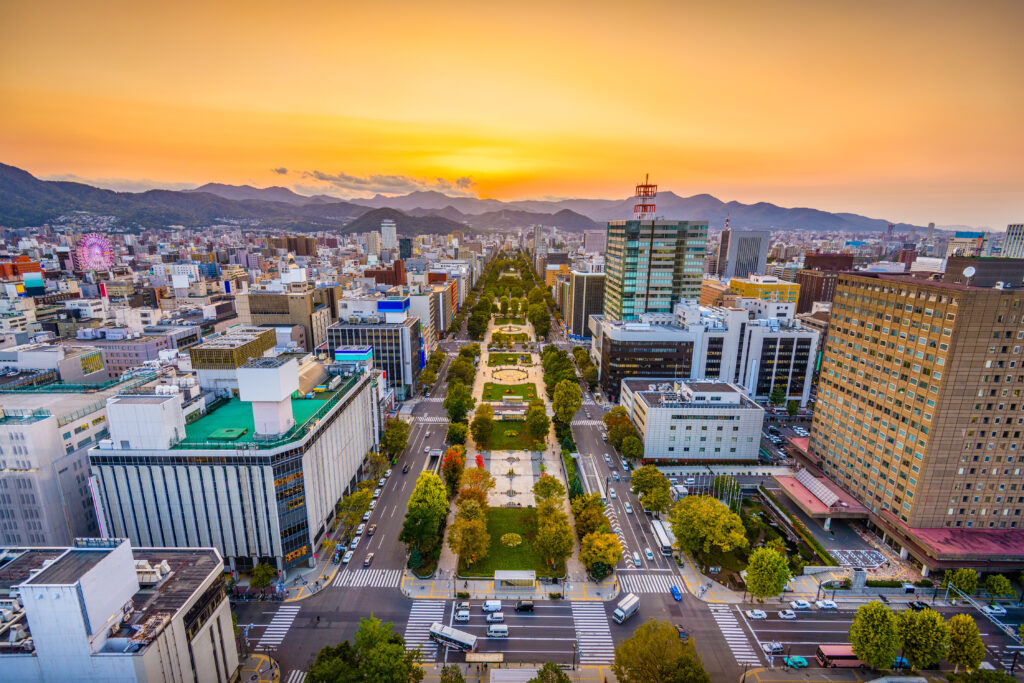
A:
809,273,1024,570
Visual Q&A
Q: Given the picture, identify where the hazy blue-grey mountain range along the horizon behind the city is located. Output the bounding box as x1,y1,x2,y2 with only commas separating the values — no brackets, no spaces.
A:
0,164,923,234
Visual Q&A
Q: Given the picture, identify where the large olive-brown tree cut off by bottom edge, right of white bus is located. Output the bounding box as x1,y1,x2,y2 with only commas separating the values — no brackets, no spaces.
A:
611,618,711,683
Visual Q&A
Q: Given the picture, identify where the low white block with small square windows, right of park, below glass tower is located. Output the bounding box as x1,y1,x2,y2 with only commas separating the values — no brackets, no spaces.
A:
622,378,764,464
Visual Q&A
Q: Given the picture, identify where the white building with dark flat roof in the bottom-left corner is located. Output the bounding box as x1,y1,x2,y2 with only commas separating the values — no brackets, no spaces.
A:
0,539,239,683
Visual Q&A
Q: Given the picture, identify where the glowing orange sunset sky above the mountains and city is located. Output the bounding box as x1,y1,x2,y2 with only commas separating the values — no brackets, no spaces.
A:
0,0,1024,229
